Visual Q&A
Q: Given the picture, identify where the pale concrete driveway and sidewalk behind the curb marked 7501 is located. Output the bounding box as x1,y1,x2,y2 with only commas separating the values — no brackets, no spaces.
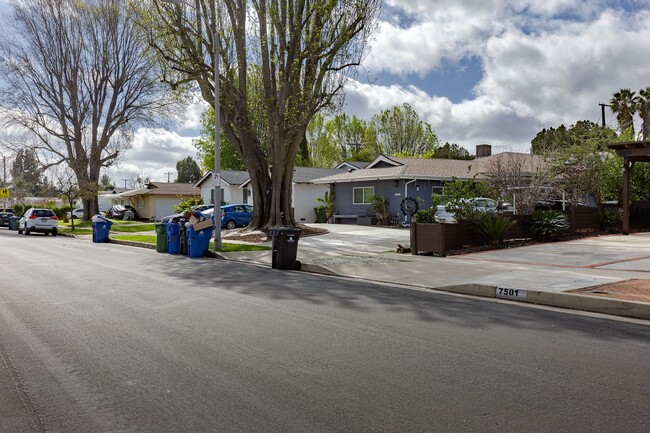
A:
220,224,650,320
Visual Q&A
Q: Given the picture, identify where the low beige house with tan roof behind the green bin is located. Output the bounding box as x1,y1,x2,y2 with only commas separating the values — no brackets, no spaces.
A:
119,182,201,221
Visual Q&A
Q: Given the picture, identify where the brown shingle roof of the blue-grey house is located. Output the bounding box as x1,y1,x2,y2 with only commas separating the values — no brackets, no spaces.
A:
313,152,543,184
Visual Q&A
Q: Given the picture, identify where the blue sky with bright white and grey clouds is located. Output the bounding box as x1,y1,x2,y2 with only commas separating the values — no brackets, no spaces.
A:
0,0,650,186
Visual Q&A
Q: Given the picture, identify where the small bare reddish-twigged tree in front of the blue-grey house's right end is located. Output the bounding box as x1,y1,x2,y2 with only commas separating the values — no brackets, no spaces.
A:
481,152,555,213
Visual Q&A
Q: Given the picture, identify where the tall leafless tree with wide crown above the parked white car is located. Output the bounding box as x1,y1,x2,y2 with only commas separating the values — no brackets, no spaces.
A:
0,0,168,215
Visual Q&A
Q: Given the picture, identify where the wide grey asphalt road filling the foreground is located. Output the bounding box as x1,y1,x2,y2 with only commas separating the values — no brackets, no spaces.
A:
0,229,650,433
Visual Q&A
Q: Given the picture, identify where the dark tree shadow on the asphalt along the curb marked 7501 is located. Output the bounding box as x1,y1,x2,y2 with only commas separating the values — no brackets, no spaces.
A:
149,253,650,339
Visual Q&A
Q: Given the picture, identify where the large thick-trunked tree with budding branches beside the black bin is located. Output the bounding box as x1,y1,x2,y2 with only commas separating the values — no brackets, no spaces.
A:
147,0,381,228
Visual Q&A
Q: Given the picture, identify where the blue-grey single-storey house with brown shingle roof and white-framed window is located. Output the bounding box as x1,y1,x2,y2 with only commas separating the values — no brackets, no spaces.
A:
312,145,538,223
